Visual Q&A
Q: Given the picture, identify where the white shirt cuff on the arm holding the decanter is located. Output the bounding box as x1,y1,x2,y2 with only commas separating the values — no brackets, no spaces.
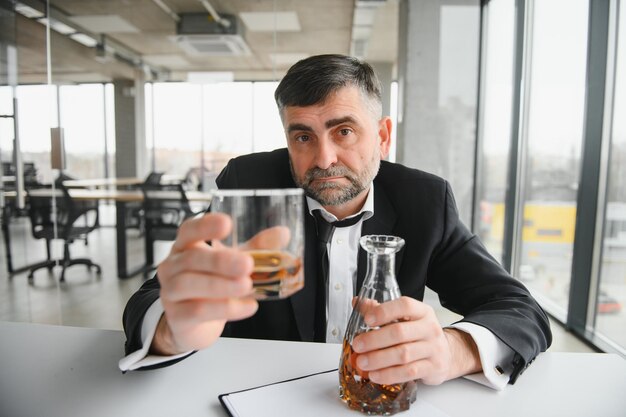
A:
449,321,515,391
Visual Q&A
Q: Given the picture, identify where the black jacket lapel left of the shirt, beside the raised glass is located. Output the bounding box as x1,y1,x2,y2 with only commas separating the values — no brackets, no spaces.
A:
291,204,318,342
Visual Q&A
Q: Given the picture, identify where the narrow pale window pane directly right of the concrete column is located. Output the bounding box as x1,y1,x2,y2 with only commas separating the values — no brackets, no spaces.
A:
436,1,480,224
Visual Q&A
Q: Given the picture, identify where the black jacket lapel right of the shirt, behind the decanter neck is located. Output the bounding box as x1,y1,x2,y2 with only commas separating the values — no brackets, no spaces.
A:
355,184,394,295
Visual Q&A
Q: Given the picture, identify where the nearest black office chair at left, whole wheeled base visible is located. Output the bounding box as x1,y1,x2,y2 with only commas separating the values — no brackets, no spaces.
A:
27,186,102,283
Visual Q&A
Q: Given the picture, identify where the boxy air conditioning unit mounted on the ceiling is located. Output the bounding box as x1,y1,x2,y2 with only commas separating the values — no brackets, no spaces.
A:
174,13,250,56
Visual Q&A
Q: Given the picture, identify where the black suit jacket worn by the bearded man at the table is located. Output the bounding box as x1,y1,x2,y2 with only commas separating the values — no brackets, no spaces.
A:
124,149,551,382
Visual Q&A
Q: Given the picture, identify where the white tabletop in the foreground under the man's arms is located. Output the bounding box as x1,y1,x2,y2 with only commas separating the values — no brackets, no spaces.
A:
0,323,626,417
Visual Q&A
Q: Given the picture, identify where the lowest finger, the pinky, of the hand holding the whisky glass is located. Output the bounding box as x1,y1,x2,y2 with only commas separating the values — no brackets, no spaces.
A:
163,298,259,327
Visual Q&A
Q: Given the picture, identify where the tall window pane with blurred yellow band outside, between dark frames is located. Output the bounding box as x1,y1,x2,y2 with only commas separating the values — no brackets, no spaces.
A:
515,0,589,314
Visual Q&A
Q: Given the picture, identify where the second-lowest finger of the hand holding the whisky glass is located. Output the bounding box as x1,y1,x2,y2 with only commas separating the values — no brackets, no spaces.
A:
161,272,252,302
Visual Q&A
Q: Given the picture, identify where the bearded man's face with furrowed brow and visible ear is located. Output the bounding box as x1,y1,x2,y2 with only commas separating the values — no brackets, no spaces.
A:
282,86,391,206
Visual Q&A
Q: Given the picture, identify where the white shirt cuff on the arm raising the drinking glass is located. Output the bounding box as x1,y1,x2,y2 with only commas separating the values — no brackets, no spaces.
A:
118,298,192,371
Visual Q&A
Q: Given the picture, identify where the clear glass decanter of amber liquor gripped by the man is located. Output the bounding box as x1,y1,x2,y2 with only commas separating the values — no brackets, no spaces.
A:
339,235,417,415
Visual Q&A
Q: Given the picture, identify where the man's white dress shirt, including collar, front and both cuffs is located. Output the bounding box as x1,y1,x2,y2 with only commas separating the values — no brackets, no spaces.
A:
119,184,515,390
